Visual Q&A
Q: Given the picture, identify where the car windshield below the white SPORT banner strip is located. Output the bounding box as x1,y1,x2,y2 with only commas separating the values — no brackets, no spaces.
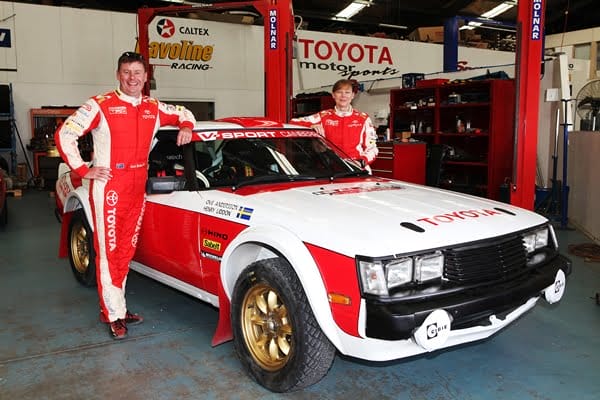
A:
193,136,364,187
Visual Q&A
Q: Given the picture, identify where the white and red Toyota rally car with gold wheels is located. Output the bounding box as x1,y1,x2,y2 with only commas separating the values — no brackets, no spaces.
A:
56,118,571,392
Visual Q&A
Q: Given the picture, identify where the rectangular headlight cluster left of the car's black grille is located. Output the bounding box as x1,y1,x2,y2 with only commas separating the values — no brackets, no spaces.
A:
358,251,444,296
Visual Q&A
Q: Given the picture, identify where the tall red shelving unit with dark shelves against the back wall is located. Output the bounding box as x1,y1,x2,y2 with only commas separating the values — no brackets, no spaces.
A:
390,79,515,200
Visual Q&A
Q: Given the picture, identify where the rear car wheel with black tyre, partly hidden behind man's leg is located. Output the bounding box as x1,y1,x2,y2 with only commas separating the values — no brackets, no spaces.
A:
68,209,96,287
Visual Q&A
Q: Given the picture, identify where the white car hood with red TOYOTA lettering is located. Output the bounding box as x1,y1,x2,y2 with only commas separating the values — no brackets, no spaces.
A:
237,178,546,256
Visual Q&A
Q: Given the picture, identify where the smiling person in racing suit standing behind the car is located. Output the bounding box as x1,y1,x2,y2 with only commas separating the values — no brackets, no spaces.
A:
291,79,378,167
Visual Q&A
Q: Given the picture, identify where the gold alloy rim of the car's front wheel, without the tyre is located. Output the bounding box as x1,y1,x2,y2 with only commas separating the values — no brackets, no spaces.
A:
241,284,293,371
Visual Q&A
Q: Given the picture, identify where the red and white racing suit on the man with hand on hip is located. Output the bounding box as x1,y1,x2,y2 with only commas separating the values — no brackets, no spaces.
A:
55,90,195,321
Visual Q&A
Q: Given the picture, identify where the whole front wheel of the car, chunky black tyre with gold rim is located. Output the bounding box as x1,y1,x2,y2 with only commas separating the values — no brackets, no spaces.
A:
231,258,335,392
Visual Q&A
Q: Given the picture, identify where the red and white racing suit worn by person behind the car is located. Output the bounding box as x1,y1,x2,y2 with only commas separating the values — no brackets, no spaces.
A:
290,109,378,165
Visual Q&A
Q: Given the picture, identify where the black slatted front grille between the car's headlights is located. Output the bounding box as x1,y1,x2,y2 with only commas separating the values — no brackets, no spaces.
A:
443,236,527,285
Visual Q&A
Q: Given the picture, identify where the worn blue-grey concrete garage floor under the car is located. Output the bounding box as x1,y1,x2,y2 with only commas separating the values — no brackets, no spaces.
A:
0,190,600,400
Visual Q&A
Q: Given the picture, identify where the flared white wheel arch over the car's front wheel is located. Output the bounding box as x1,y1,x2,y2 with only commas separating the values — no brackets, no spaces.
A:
220,226,341,349
